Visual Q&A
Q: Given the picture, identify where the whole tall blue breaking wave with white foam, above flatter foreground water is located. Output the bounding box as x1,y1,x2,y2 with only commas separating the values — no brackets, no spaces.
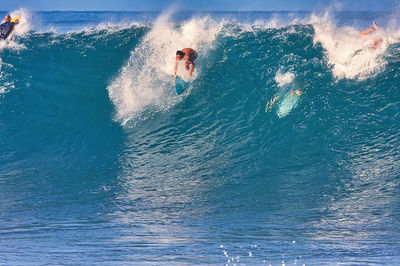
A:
1,17,399,175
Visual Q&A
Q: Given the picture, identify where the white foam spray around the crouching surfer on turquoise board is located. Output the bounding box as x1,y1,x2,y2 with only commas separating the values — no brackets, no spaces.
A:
108,12,220,124
